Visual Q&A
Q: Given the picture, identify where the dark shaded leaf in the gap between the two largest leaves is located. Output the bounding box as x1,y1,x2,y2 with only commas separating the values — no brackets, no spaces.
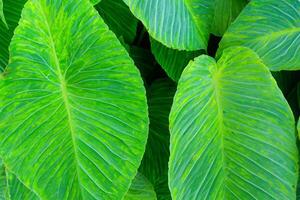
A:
139,79,176,199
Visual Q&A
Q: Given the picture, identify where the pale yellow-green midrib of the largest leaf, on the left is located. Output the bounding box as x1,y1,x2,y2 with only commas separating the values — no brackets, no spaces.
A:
38,1,82,198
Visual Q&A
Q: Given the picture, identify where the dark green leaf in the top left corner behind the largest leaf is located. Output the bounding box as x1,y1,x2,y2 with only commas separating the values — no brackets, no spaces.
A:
0,0,26,72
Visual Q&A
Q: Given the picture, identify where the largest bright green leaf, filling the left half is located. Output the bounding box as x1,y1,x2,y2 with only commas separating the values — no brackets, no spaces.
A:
0,0,148,199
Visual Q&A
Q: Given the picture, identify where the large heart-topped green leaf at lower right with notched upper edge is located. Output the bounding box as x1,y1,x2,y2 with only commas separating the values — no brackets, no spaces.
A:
169,47,298,199
